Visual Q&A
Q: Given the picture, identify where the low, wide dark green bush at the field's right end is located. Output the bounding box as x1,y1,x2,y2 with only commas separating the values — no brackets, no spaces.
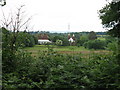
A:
84,40,106,49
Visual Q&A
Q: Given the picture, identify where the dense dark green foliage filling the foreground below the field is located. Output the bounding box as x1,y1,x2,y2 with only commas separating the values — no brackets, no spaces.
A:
3,48,120,89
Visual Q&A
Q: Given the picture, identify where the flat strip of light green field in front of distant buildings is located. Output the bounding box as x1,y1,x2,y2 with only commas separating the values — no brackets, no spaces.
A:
24,45,109,56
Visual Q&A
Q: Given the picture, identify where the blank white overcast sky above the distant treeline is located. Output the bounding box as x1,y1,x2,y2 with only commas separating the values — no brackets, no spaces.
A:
0,0,107,32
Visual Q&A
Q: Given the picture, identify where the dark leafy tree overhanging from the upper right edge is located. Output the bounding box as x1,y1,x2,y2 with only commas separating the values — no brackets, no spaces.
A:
99,1,120,65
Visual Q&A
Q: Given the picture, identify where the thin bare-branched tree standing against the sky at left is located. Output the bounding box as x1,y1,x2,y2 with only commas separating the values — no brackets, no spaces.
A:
1,5,31,51
